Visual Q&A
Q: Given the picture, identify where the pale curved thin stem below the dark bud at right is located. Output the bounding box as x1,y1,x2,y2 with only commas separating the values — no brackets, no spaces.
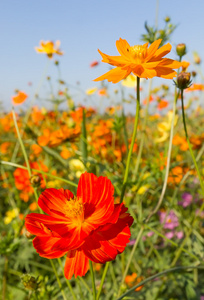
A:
146,88,179,223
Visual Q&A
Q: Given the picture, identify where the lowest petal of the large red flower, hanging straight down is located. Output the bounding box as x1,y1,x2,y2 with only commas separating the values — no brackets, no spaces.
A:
64,250,89,279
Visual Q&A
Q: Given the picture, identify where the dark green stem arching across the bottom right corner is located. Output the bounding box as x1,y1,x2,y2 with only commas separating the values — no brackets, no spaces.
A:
117,266,204,300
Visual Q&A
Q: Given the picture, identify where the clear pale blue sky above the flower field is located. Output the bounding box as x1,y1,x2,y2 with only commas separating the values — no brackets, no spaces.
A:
0,0,204,108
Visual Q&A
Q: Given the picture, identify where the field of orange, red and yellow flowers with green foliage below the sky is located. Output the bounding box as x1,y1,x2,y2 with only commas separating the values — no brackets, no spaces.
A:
0,18,204,300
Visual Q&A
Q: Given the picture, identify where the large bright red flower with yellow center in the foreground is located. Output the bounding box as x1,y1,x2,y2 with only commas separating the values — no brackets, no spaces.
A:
25,173,133,279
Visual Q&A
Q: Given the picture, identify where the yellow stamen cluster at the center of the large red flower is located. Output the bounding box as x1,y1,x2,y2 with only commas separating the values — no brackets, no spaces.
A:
65,197,84,222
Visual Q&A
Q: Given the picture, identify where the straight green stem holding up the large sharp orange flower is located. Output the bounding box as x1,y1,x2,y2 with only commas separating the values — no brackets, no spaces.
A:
120,77,140,203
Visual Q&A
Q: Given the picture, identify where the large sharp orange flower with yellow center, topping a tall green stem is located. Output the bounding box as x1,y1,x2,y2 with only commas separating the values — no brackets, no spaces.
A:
94,38,182,83
